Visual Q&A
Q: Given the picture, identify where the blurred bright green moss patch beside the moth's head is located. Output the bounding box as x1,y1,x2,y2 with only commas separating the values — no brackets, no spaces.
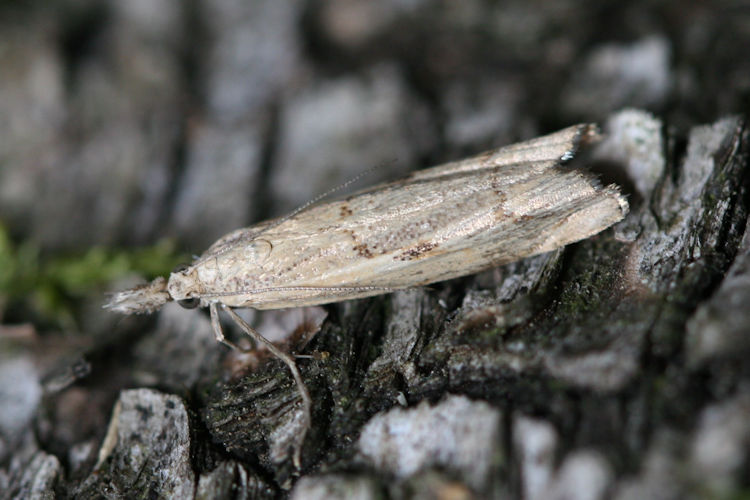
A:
0,224,185,329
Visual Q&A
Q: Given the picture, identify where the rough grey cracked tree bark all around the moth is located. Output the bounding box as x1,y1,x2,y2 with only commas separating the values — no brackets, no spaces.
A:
0,0,750,500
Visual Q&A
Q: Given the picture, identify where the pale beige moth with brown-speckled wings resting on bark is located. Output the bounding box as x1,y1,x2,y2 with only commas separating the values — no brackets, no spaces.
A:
105,124,628,465
